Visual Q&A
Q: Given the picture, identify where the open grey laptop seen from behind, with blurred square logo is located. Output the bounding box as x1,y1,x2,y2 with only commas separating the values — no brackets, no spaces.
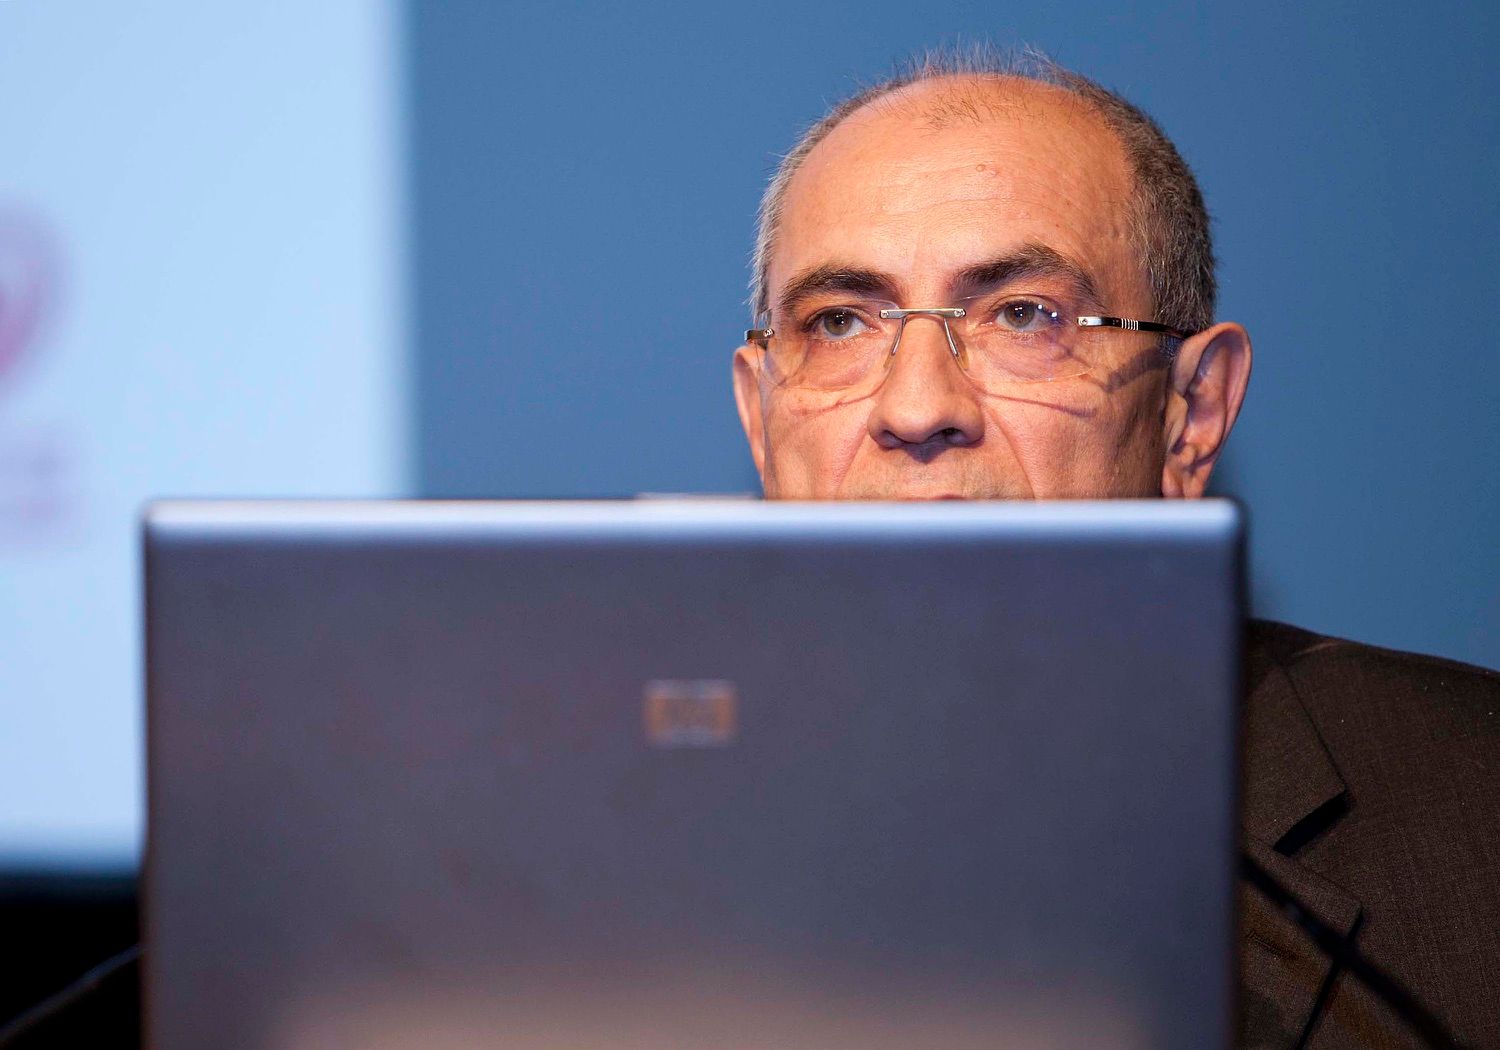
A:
143,501,1242,1050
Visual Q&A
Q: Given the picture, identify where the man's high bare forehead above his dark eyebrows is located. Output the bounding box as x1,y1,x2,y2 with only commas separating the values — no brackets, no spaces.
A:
767,80,1145,306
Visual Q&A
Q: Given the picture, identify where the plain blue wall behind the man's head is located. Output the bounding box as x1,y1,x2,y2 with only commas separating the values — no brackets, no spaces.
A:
408,0,1500,666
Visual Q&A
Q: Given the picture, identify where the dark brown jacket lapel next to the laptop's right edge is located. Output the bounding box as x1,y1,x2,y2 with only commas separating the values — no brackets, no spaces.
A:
1238,644,1361,1050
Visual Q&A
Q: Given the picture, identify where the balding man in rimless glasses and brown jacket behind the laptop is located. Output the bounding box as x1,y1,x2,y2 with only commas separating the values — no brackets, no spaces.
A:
734,51,1500,1049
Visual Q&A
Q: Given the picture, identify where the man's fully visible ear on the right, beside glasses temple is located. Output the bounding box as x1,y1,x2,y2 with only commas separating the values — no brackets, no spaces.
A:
1161,321,1251,500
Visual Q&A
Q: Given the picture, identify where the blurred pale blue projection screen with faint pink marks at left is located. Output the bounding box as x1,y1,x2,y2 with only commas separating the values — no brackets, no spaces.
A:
0,0,407,872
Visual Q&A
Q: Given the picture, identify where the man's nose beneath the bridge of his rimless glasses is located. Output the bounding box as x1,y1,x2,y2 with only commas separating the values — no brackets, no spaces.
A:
869,314,984,453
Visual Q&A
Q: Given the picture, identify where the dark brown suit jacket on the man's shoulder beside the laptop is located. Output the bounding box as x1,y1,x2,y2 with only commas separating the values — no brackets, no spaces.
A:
1239,623,1500,1050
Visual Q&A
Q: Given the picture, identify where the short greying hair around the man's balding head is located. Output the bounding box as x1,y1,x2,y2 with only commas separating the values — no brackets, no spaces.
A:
750,45,1217,333
